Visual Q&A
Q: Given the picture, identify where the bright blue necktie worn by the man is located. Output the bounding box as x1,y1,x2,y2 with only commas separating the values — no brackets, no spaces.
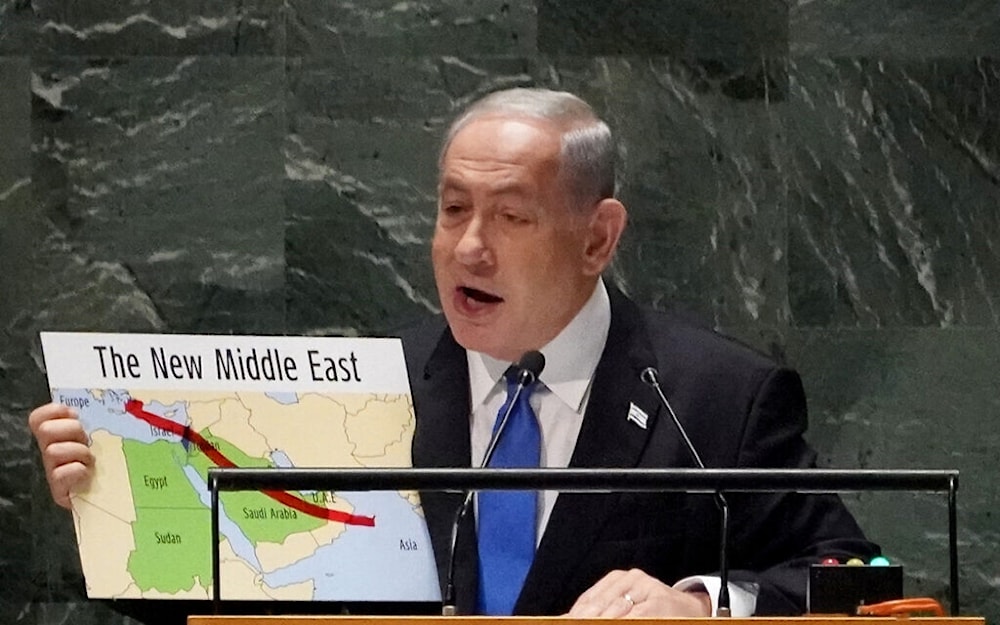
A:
476,376,541,616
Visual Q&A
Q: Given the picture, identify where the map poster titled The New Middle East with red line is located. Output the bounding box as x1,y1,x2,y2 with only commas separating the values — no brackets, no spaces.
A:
41,332,440,602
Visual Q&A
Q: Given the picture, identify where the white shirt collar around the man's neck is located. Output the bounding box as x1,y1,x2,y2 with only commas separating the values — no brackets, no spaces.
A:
467,280,611,412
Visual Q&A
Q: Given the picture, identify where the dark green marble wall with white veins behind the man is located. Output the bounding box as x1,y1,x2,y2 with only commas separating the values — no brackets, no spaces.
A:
0,0,1000,625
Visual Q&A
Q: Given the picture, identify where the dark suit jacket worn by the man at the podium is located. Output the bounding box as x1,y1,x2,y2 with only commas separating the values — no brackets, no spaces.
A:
403,288,877,614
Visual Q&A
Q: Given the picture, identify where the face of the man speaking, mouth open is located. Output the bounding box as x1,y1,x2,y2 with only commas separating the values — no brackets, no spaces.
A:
432,117,603,361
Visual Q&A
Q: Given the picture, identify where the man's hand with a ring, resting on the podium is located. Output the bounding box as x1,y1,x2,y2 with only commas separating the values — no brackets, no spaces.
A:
567,569,712,618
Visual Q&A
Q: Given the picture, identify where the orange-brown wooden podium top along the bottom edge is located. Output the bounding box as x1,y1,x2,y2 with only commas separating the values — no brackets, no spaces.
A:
188,616,986,625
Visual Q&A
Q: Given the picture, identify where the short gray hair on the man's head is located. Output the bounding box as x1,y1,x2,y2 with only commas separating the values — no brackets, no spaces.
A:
438,88,615,207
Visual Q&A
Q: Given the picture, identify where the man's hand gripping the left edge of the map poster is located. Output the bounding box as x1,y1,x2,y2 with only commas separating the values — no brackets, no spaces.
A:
28,403,94,509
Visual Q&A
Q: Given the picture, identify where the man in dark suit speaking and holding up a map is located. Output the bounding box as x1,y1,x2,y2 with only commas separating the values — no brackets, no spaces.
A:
29,89,876,617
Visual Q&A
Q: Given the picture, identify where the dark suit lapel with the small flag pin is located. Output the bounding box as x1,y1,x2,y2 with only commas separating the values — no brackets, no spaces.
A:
514,287,659,614
